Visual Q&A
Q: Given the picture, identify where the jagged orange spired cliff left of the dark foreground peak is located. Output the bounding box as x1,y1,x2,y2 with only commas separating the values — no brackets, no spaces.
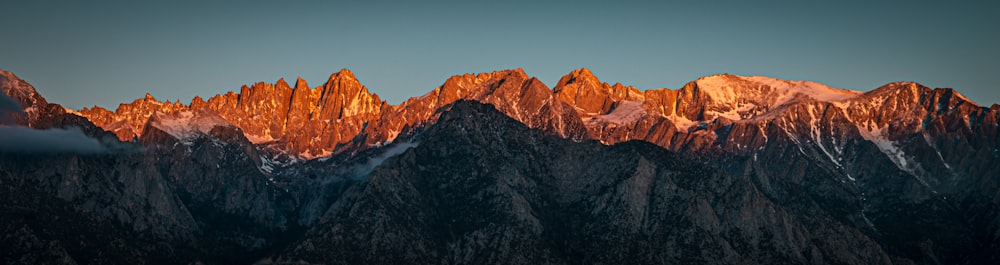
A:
80,69,386,158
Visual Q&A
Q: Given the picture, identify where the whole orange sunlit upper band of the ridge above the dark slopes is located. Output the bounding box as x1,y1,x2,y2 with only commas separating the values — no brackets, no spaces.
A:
79,68,1000,159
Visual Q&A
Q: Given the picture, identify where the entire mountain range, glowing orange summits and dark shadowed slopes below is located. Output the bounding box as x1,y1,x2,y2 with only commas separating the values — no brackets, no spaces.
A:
0,68,1000,264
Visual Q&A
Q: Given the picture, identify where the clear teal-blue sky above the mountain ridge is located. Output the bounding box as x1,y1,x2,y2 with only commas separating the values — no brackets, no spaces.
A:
0,0,1000,109
